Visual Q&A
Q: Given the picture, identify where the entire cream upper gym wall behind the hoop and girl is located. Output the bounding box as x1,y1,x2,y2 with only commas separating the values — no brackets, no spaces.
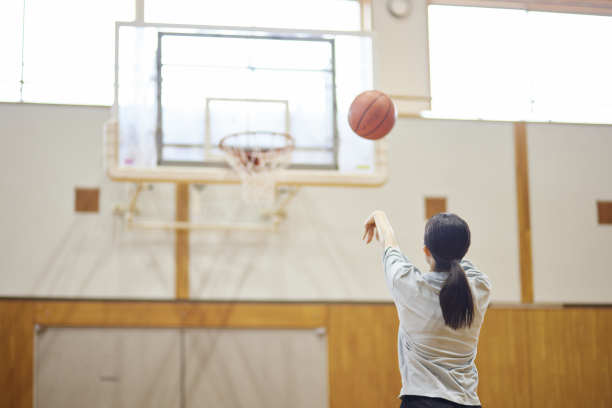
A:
0,0,612,303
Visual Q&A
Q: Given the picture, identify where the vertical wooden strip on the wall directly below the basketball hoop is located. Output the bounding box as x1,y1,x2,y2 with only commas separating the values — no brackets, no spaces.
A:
174,183,189,300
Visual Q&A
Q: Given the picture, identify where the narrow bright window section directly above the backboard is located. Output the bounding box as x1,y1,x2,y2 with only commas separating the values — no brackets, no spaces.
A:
145,0,361,31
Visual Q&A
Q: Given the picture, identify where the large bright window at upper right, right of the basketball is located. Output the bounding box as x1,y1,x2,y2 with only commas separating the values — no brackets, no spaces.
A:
429,5,612,123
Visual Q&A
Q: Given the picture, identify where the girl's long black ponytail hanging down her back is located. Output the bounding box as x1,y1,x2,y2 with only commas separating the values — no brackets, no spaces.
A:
440,259,474,330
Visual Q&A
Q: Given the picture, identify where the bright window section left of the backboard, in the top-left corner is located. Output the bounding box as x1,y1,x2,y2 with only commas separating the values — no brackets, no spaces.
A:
0,0,134,105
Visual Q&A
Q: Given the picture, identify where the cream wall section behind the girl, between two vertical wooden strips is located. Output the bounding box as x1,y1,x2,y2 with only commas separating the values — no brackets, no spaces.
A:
190,120,520,301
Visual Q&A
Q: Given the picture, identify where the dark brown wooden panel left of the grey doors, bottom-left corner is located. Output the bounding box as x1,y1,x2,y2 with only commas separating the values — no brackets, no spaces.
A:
0,300,34,408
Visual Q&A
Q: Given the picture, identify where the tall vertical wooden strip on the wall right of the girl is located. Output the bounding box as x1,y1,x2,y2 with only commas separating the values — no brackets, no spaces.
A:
514,122,534,303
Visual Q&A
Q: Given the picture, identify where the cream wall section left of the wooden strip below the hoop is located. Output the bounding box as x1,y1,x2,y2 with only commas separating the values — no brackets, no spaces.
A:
0,104,174,298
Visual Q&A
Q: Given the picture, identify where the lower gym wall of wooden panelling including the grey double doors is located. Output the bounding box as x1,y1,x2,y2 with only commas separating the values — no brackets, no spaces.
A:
0,300,612,408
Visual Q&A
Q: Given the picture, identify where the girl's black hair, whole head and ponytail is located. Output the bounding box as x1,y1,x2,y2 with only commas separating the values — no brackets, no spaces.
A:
425,213,474,330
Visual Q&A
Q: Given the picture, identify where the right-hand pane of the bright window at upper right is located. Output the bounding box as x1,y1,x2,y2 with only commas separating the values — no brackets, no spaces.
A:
528,12,612,122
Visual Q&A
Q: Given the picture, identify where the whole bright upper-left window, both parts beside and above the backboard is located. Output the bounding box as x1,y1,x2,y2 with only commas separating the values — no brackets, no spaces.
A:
0,0,361,105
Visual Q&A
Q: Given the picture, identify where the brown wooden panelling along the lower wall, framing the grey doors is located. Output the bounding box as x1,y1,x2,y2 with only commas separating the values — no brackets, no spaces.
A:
0,300,612,408
